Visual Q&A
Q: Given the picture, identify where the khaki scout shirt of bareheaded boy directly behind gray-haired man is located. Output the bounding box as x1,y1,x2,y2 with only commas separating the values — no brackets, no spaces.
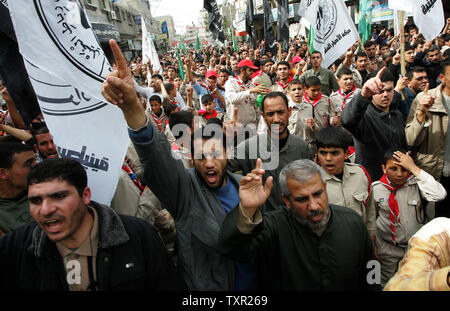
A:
325,163,377,236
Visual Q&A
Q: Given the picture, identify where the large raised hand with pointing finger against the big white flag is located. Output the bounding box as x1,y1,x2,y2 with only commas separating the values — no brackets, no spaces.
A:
102,40,147,129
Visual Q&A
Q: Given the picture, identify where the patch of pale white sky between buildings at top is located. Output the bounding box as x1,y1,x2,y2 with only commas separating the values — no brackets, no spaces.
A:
150,0,227,33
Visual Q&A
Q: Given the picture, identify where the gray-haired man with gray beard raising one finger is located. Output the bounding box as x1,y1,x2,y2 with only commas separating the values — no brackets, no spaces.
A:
219,159,380,291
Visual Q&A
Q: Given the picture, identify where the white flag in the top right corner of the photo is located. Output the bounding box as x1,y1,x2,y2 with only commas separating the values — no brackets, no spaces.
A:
389,0,445,41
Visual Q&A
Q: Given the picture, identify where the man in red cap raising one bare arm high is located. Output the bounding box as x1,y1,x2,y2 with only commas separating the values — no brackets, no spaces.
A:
185,59,226,113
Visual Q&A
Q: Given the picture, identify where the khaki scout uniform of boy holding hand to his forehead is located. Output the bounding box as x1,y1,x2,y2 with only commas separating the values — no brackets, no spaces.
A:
369,170,447,286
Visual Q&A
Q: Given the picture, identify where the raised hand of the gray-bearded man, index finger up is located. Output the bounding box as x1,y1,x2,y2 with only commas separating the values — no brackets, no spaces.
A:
239,158,273,218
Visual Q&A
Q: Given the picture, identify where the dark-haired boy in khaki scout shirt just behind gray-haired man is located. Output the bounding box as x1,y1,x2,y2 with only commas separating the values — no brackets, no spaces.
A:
316,127,376,247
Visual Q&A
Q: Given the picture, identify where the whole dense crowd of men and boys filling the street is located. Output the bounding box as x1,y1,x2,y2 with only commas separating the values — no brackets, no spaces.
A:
0,19,450,291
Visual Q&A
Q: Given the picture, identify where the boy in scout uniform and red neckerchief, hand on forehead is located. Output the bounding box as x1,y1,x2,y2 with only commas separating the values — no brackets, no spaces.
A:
369,151,447,287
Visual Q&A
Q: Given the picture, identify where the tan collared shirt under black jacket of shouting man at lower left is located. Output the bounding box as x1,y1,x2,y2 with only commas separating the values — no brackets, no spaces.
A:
55,206,98,291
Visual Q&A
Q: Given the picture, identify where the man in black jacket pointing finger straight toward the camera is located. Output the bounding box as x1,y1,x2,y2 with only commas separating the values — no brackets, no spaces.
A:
341,67,407,180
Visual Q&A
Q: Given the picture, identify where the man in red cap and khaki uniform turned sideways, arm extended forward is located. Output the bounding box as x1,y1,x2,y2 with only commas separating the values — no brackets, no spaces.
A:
225,59,270,132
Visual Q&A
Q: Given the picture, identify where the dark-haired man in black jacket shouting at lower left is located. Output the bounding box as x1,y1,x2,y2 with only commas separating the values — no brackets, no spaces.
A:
0,159,185,291
